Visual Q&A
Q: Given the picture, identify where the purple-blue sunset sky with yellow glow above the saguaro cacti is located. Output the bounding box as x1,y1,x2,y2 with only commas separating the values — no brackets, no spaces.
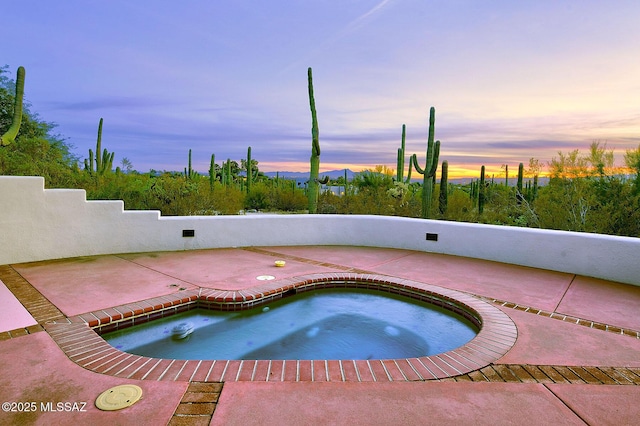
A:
0,0,640,178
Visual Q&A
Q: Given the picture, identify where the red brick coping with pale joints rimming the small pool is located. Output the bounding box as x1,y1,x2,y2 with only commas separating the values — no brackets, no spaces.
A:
45,273,517,382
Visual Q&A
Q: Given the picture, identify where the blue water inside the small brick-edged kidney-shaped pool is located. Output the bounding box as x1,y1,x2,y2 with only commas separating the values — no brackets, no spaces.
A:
102,289,478,360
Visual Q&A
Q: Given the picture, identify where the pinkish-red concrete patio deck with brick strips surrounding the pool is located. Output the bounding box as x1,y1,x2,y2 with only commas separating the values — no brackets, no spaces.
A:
0,246,640,426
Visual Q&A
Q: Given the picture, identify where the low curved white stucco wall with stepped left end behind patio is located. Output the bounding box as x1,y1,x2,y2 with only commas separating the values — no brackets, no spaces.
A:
0,176,640,285
